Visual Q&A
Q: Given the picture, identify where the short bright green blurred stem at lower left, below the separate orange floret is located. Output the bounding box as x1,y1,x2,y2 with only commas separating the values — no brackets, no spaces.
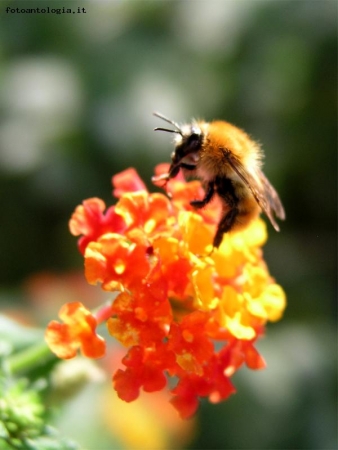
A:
7,342,56,375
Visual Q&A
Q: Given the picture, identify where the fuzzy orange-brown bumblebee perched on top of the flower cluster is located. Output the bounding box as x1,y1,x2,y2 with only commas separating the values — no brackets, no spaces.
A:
153,113,285,247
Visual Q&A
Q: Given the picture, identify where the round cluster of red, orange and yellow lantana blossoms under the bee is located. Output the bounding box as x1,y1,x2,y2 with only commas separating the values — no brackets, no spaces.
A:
46,164,286,418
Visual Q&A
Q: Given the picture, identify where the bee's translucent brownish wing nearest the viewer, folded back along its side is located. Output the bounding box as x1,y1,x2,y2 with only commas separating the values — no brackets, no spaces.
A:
224,151,285,231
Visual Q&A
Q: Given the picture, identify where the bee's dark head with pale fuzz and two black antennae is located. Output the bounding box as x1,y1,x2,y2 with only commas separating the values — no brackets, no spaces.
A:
154,113,203,164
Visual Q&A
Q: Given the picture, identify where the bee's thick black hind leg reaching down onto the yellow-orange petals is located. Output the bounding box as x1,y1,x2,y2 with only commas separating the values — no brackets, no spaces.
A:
213,178,239,247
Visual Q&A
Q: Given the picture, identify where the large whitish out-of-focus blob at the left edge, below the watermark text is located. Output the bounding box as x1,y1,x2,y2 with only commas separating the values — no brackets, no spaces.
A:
0,55,83,172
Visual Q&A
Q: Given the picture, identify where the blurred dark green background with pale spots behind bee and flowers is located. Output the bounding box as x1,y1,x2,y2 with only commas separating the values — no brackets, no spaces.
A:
0,0,337,450
